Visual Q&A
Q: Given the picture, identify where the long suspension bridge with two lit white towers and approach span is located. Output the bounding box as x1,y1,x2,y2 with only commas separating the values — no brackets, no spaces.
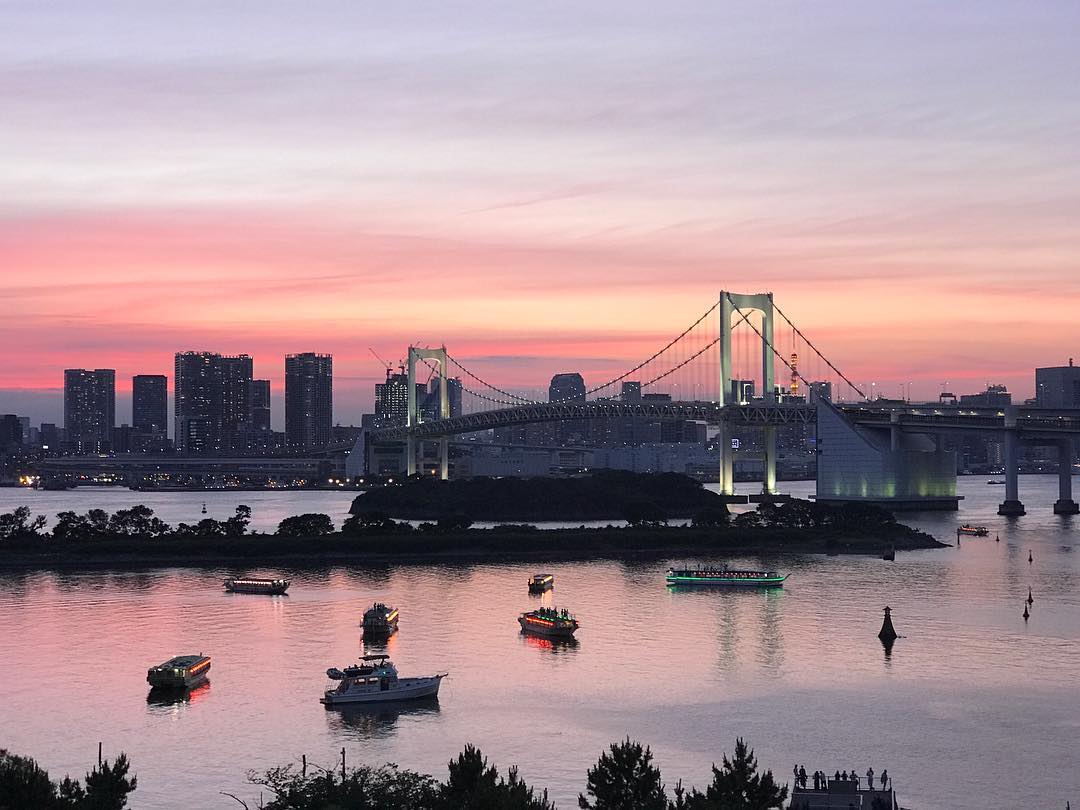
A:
353,292,1080,514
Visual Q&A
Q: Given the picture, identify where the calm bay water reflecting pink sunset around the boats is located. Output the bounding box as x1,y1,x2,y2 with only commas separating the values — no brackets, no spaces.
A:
0,476,1080,810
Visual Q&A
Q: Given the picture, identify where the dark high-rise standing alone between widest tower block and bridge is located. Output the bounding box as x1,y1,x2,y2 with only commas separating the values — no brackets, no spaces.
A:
285,352,334,448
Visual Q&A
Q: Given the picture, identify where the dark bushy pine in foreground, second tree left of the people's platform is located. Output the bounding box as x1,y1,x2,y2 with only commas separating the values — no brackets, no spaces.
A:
578,737,667,810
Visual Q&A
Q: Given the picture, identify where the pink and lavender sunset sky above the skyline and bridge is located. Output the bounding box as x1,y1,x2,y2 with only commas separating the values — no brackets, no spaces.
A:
0,0,1080,432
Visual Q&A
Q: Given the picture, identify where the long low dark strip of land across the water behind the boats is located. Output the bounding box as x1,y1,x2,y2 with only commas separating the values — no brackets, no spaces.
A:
0,527,951,572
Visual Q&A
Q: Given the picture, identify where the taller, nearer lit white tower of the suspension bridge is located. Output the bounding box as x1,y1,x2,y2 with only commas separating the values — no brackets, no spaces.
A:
719,291,777,495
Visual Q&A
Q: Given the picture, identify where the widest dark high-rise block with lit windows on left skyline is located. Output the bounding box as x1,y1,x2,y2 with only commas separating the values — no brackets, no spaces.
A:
173,352,252,456
